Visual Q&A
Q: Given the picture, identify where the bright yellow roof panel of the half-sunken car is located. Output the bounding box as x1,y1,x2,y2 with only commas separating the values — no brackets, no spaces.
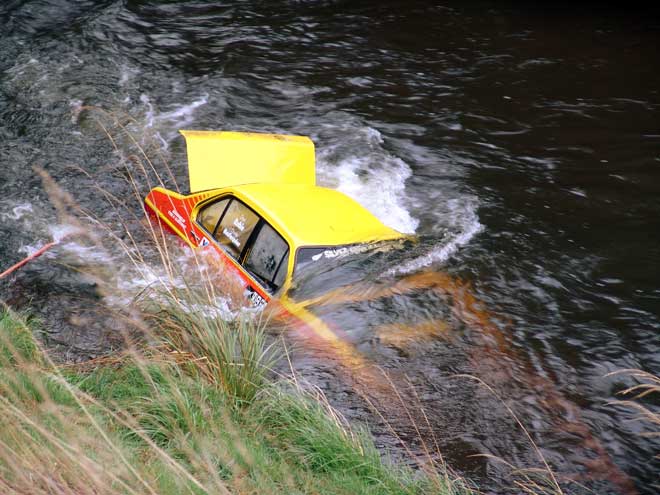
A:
222,183,403,249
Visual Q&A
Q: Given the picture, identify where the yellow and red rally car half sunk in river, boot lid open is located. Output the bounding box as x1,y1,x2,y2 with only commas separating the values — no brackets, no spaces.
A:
145,131,406,306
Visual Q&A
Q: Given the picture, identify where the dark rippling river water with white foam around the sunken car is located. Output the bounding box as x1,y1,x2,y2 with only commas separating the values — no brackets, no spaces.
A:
0,0,660,493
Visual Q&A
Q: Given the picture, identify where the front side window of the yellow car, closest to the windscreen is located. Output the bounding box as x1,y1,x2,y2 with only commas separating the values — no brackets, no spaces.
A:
244,222,289,290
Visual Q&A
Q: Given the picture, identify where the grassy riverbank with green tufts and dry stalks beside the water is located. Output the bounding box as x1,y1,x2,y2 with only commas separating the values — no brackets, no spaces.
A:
0,307,469,494
